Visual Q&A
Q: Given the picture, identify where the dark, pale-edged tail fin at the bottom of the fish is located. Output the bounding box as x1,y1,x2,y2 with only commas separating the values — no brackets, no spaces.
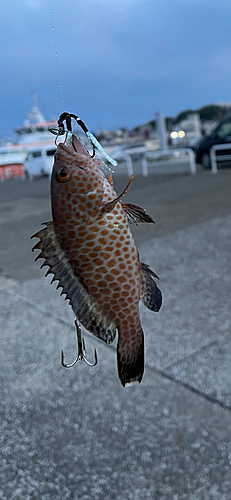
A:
117,325,144,387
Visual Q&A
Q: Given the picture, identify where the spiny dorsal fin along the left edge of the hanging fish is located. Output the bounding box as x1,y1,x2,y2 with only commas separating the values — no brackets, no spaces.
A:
32,222,116,344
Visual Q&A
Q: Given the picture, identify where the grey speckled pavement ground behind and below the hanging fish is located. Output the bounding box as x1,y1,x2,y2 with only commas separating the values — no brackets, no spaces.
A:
0,169,231,500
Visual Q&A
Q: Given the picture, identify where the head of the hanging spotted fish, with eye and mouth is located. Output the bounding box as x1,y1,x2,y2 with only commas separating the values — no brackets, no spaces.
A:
50,134,104,220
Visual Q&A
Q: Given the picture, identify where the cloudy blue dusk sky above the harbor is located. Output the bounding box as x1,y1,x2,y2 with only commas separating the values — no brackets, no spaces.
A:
0,0,231,138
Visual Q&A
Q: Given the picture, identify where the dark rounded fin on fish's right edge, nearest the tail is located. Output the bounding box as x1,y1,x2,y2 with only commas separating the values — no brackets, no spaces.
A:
140,262,162,312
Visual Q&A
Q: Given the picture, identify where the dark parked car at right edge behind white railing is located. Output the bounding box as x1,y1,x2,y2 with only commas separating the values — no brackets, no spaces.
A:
195,117,231,168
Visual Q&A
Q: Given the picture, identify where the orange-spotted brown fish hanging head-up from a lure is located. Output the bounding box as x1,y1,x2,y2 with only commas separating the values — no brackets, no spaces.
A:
33,133,162,387
